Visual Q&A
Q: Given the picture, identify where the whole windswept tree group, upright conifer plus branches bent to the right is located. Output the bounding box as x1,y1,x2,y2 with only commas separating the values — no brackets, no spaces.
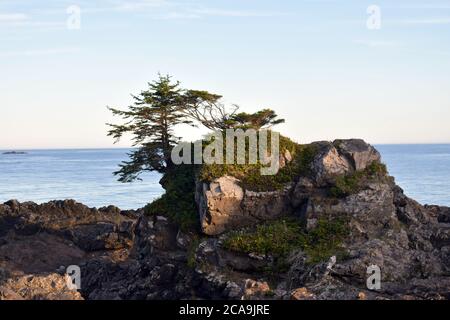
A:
108,75,284,182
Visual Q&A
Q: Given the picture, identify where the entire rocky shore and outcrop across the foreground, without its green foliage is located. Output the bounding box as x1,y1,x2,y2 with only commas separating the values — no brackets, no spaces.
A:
0,140,450,300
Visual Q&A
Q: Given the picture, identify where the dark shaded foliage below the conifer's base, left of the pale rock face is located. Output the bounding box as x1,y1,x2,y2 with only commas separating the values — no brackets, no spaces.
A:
145,165,199,230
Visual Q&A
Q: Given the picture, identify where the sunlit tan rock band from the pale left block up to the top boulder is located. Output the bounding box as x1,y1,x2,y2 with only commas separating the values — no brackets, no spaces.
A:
196,139,381,235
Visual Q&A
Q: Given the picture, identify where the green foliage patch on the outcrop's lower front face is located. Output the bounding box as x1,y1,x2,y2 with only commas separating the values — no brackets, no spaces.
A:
223,218,348,269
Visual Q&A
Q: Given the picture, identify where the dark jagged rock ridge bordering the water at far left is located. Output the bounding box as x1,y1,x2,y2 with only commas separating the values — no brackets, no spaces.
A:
0,200,132,251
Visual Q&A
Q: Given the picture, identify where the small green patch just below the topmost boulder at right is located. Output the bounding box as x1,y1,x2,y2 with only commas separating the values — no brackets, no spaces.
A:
330,161,388,198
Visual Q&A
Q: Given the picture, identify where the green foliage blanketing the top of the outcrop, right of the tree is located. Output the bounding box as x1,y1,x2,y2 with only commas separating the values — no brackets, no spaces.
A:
199,135,317,191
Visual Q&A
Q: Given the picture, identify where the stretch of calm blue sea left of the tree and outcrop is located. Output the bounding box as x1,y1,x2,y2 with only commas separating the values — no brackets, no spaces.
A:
0,149,163,209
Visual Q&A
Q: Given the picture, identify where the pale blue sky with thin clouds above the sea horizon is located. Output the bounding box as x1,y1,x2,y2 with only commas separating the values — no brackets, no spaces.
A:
0,0,450,149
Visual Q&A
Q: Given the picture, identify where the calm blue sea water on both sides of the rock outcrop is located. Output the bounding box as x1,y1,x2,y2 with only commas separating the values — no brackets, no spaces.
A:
0,145,450,209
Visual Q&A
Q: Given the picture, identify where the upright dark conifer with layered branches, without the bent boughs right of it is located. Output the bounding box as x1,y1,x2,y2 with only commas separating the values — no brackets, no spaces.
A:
108,75,192,182
